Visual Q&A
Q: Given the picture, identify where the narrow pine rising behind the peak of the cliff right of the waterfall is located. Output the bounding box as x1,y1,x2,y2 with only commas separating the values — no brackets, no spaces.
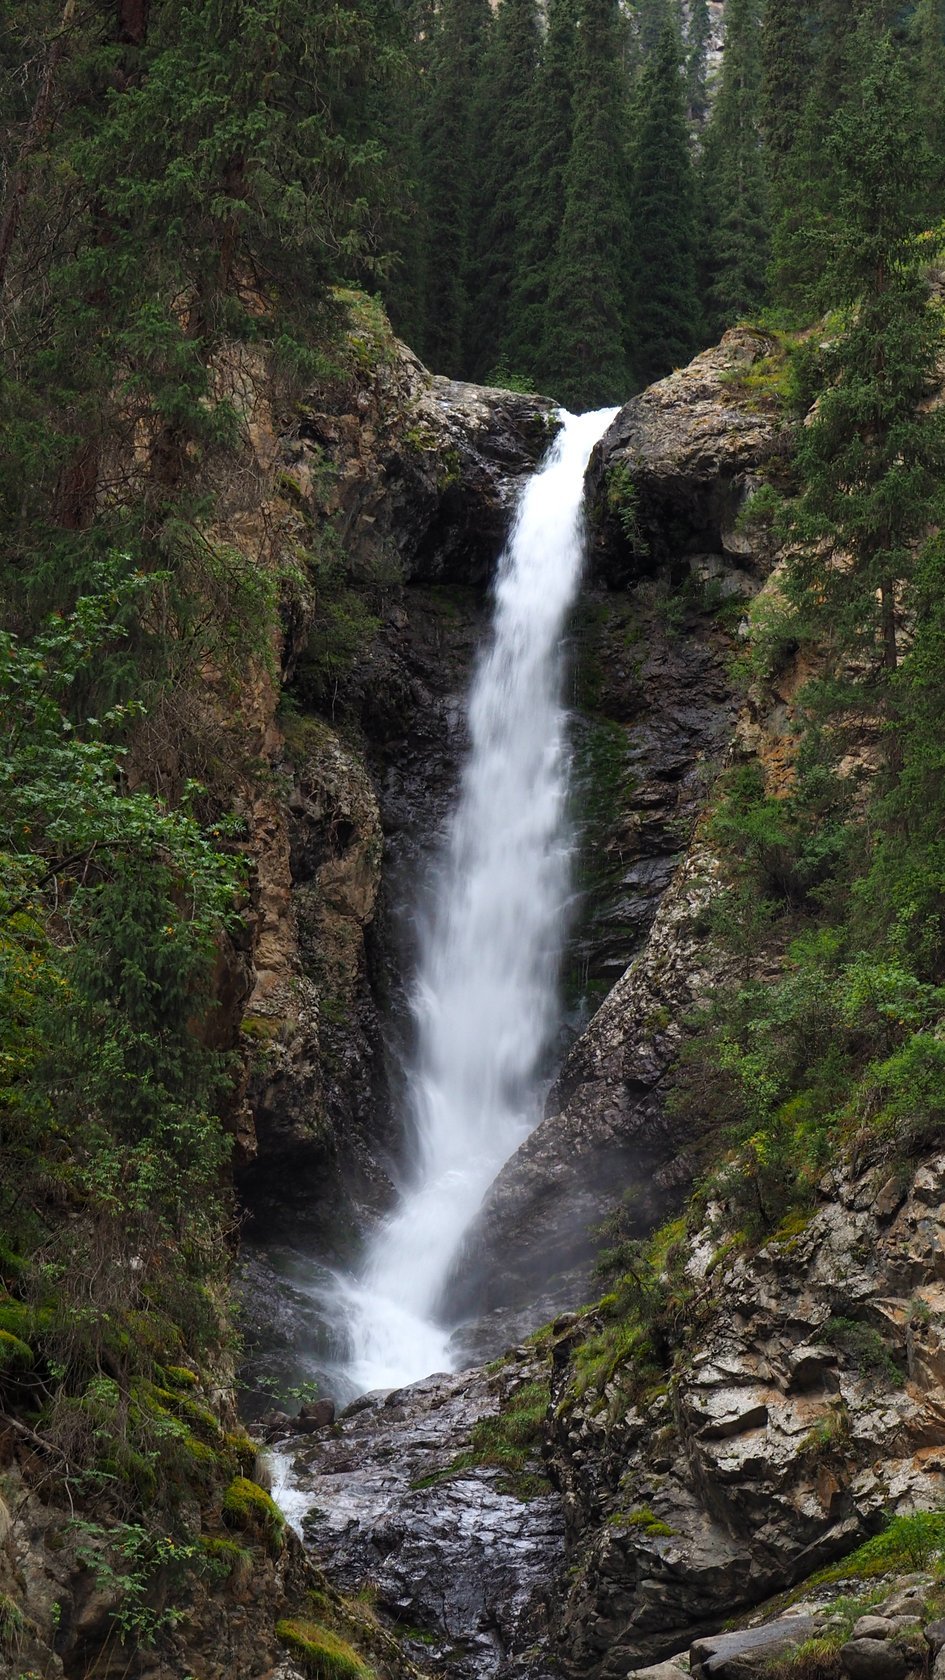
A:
701,0,768,333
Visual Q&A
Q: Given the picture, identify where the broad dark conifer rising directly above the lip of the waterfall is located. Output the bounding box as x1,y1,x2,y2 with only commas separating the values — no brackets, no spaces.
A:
540,0,631,408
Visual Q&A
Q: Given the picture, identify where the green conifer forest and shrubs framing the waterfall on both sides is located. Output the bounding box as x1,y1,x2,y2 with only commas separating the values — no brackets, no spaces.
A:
0,0,945,1680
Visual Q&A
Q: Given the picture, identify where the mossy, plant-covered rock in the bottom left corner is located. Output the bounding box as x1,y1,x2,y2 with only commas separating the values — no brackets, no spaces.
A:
0,1433,422,1680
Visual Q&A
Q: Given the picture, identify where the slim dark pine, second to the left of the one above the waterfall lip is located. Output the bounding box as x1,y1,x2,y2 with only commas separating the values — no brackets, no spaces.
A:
464,0,540,380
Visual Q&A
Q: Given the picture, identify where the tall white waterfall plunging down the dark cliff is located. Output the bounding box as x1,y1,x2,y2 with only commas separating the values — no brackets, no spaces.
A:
330,410,617,1393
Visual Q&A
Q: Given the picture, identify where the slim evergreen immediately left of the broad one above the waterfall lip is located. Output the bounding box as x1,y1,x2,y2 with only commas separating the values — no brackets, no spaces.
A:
499,0,578,386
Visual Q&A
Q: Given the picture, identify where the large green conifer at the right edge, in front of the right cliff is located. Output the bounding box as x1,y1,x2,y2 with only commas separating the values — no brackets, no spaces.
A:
795,22,945,675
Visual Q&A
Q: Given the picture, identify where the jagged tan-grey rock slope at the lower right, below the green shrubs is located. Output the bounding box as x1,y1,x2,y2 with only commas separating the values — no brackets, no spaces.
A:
552,1156,945,1680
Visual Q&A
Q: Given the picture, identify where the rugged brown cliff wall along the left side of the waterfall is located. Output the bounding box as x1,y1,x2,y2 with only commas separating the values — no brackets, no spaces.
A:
234,312,555,1248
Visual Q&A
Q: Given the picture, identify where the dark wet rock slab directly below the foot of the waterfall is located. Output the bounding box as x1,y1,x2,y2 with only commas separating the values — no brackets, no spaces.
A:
274,1349,563,1680
